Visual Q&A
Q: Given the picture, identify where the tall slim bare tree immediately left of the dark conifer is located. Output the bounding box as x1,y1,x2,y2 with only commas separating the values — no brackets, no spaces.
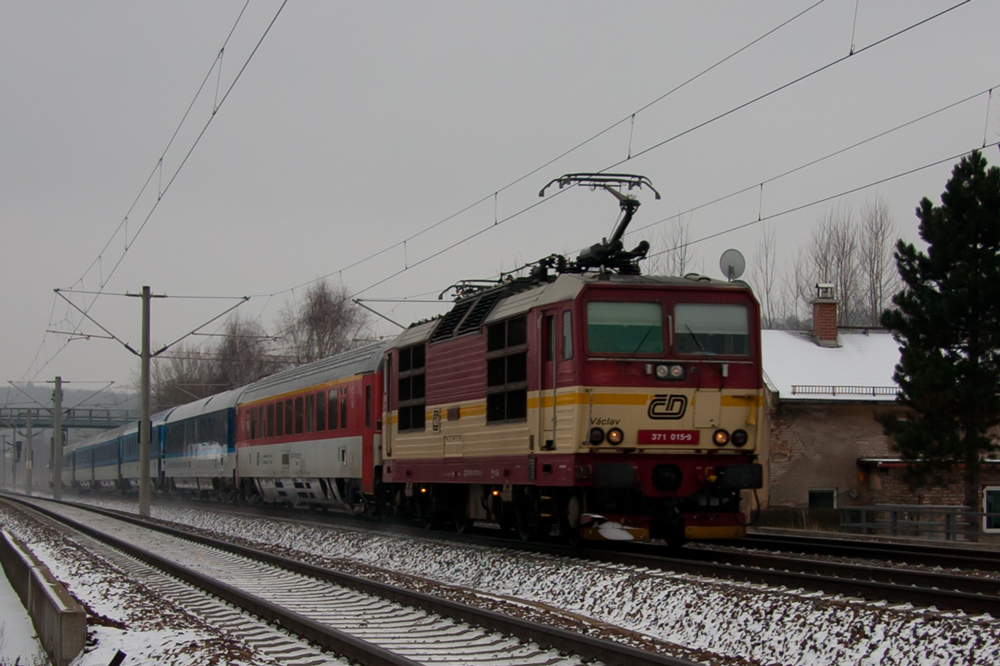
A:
858,197,900,326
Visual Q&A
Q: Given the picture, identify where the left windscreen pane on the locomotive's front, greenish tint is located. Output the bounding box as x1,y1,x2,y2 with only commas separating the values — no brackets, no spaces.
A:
587,301,663,354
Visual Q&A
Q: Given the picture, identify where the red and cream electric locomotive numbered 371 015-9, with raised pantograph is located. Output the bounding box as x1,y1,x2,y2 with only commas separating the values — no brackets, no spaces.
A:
382,174,763,542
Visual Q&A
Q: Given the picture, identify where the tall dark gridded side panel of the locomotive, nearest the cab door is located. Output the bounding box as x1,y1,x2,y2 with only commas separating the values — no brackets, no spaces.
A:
486,317,528,423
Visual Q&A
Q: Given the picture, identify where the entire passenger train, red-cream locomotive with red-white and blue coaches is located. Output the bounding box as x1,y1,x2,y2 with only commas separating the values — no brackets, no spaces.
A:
63,174,764,543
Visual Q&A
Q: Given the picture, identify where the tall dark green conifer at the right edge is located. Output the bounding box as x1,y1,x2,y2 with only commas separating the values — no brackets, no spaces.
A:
882,151,1000,536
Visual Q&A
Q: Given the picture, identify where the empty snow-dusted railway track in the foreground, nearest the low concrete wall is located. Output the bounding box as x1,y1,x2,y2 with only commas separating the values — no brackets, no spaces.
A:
1,498,704,666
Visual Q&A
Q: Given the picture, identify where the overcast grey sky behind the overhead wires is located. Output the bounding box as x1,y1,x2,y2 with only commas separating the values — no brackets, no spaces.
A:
0,0,1000,400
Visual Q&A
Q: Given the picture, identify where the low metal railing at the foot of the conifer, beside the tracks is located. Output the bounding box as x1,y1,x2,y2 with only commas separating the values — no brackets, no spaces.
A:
840,504,1000,541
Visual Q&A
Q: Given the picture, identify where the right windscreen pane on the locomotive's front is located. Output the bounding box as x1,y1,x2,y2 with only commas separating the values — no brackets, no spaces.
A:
674,303,750,356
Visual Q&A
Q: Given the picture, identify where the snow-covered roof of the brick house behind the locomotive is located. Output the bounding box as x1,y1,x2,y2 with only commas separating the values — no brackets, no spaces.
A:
761,329,899,402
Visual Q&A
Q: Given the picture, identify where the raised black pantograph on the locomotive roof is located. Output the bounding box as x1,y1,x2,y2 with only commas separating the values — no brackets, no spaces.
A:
538,173,660,275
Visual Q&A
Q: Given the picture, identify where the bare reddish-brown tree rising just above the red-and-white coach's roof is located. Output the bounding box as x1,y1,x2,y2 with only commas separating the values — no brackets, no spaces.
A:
280,280,368,365
